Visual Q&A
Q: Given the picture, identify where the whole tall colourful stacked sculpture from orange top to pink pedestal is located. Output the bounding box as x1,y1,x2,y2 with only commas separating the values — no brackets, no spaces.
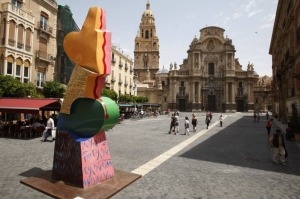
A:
52,8,119,188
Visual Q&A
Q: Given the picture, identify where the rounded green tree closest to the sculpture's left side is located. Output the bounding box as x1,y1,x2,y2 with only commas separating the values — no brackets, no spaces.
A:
43,81,66,98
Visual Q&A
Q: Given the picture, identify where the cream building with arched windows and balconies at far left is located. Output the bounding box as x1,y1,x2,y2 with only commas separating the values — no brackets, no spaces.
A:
0,0,57,88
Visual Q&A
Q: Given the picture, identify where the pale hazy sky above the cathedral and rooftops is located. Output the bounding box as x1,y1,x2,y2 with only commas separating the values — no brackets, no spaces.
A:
57,0,278,76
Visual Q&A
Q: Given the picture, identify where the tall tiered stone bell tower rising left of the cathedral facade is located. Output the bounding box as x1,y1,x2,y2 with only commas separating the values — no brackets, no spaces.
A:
134,1,159,82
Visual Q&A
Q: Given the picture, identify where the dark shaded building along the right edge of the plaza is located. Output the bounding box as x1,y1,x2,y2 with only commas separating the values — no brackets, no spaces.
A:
269,0,300,123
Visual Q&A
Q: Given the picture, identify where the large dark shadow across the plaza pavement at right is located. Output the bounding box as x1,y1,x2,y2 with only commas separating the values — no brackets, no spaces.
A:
181,116,300,175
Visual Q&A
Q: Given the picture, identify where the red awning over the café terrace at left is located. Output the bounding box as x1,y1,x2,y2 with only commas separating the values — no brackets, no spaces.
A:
0,98,61,113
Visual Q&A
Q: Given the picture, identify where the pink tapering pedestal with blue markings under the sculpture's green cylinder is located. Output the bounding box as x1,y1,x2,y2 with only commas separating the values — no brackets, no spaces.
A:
52,131,115,189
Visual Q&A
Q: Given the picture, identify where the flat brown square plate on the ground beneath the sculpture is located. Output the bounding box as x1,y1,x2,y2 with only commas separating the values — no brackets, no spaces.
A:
20,169,141,199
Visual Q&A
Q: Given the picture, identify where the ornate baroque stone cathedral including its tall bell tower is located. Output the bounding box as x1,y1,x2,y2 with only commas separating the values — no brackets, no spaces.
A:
134,2,259,112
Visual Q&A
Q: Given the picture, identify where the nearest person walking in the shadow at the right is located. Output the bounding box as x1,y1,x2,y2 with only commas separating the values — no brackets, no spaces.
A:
269,129,286,165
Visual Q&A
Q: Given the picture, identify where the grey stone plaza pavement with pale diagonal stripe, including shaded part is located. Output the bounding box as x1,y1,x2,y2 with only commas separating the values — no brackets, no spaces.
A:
0,113,300,199
